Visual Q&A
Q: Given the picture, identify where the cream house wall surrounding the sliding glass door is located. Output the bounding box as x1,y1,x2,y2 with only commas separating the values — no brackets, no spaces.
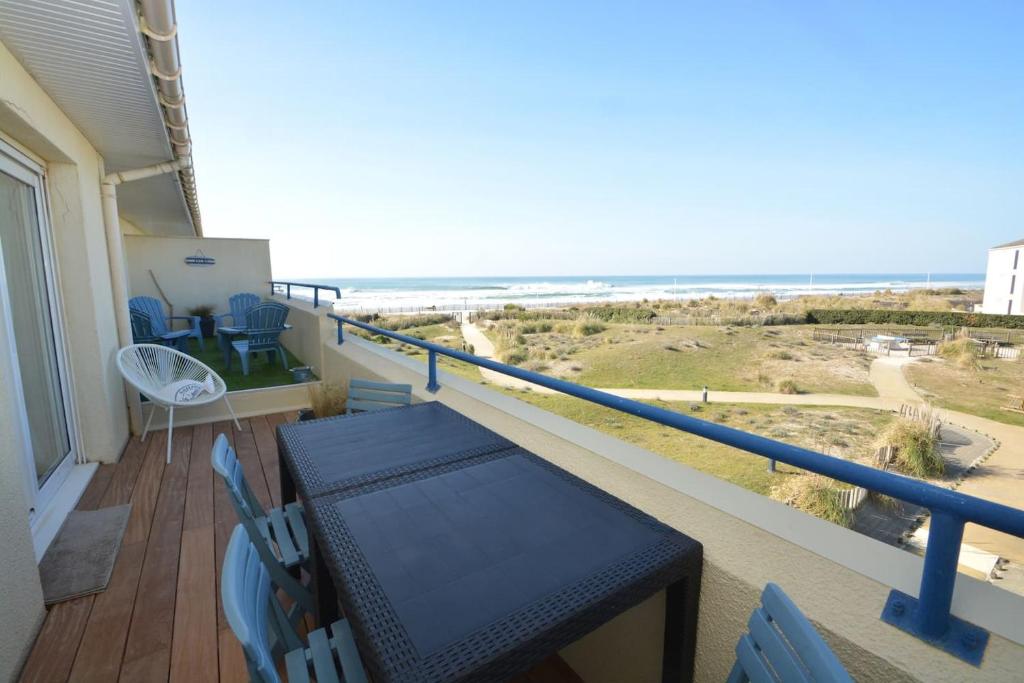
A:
0,43,136,680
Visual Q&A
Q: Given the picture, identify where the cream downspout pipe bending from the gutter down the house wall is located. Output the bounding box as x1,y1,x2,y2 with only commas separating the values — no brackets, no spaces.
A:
99,157,191,433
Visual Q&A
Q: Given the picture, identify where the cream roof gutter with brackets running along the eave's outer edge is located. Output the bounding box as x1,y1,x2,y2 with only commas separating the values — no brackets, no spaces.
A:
138,0,203,238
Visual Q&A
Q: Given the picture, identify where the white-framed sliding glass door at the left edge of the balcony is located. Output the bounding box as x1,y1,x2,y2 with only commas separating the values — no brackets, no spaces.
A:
0,143,75,512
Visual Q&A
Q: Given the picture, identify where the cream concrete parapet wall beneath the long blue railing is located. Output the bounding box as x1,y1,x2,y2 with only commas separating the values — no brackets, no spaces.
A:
323,335,1024,682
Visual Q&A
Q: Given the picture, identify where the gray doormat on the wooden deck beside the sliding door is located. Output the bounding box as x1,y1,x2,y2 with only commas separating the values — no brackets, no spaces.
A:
39,503,131,605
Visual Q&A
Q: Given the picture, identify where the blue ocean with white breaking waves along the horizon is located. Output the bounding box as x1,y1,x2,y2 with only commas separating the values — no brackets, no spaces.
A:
297,272,985,311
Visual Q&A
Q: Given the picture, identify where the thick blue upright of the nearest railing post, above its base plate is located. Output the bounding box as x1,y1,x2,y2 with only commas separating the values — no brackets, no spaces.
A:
914,511,964,638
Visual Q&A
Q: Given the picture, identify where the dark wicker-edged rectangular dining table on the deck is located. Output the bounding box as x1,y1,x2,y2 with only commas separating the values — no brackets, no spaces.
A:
278,401,702,683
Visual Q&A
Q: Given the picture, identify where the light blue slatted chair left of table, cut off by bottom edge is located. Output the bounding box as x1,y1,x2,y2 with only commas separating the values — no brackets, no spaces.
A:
220,524,368,683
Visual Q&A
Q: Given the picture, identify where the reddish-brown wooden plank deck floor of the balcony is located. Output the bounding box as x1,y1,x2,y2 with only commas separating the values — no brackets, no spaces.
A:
20,413,580,683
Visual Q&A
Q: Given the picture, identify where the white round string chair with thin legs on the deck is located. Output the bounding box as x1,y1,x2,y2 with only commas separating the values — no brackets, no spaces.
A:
118,344,242,465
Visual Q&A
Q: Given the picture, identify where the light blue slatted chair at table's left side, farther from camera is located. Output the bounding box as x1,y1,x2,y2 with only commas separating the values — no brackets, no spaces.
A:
210,434,314,625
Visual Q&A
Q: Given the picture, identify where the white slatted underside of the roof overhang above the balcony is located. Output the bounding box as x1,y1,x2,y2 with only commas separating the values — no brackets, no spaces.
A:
0,0,198,234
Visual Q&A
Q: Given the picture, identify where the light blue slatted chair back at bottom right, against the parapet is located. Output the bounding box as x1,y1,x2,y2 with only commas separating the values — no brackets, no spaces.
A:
728,584,853,683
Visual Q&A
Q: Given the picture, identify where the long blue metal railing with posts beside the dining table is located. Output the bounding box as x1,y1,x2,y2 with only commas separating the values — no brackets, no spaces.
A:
329,313,1024,666
